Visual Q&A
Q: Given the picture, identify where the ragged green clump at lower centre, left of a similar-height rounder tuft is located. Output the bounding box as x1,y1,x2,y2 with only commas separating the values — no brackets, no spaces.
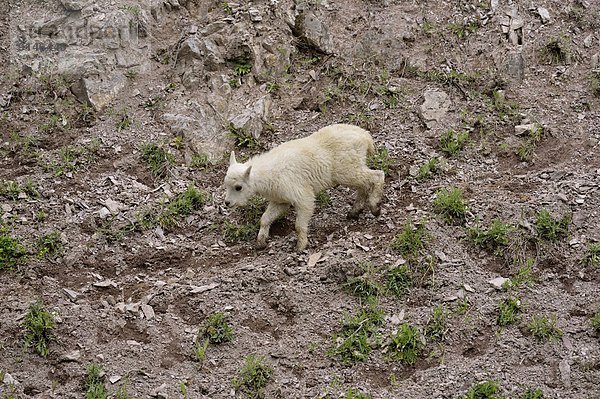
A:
328,304,383,365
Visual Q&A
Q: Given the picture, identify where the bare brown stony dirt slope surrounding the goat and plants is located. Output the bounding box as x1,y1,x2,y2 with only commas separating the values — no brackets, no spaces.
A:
0,0,600,399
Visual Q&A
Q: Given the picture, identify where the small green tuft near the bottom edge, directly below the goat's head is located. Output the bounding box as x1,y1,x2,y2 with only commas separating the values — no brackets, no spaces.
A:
233,354,273,398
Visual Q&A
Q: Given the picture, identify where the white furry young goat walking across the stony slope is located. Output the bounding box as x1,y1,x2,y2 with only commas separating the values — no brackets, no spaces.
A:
225,124,384,251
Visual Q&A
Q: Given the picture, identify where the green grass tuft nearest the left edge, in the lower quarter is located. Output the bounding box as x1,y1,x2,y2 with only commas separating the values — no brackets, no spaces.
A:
23,302,54,357
